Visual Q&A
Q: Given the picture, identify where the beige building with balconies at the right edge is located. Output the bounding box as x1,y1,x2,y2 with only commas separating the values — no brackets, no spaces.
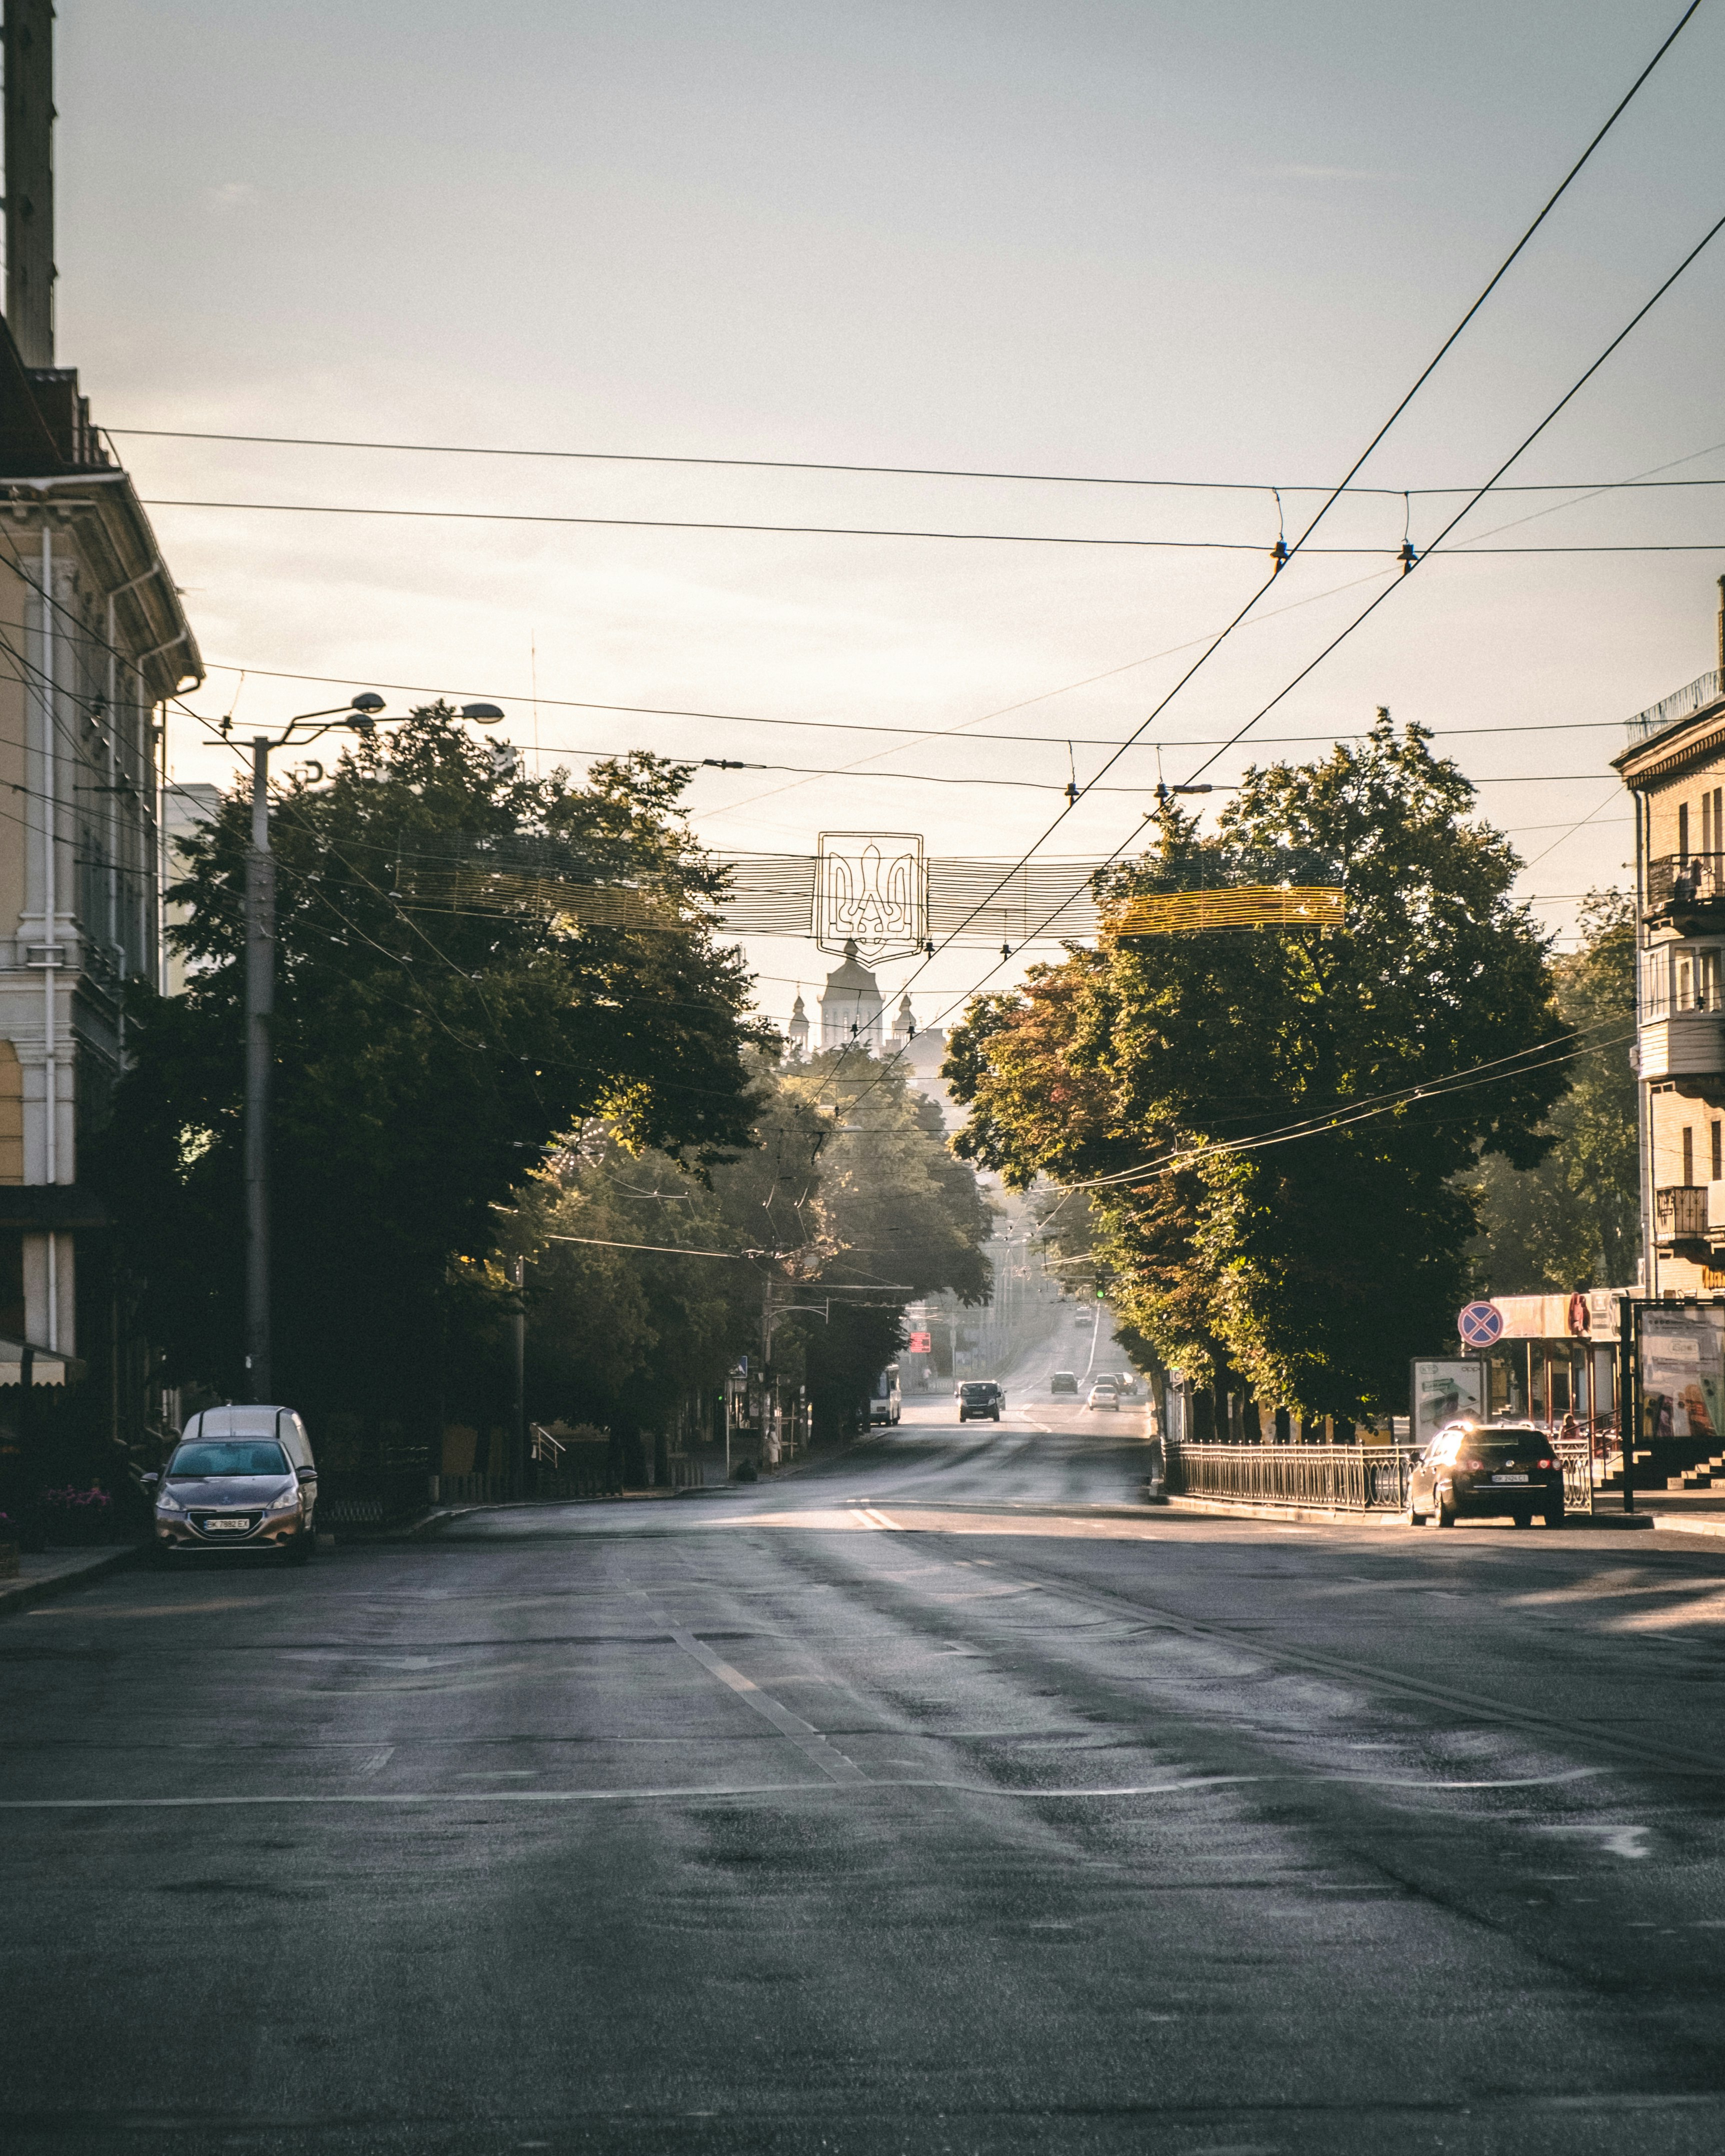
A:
1613,578,1725,1294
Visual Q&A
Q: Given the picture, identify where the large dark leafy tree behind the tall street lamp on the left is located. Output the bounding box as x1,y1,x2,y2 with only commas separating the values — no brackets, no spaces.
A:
102,705,765,1429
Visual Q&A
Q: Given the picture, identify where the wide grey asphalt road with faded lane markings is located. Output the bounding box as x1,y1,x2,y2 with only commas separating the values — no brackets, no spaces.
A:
0,1395,1725,2156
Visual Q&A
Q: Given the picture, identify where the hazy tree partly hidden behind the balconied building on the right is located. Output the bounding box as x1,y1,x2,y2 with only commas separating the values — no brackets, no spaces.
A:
1468,890,1641,1296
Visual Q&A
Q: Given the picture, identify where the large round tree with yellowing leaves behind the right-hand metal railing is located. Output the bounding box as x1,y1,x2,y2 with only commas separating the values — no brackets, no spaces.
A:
947,712,1567,1416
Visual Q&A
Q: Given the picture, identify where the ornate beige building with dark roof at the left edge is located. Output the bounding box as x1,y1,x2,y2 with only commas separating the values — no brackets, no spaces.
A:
0,324,203,1367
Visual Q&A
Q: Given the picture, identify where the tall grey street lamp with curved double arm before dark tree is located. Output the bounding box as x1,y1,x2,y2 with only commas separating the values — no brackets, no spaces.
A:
239,690,384,1401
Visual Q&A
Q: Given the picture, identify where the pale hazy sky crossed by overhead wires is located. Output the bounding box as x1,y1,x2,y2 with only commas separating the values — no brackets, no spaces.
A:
56,0,1725,1020
